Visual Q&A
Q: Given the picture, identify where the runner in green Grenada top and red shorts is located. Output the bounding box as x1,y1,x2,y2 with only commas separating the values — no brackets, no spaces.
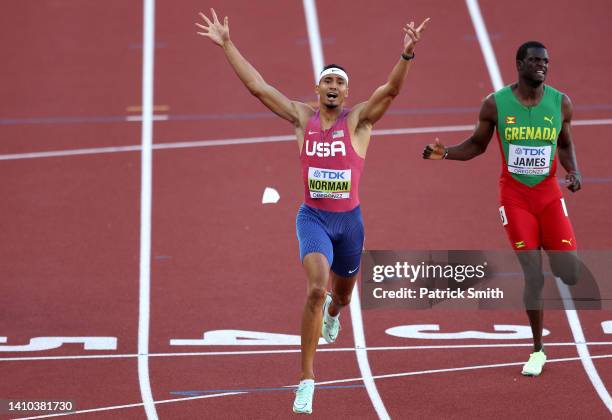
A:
423,41,581,376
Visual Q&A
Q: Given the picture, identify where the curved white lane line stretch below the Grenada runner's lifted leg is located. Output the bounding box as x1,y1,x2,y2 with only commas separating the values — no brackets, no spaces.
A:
555,277,612,413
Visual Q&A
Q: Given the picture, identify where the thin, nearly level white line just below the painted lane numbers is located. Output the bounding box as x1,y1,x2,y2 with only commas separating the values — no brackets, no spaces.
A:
0,341,612,362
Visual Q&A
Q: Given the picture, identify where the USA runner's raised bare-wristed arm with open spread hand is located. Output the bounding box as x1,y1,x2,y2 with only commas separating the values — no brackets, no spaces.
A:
196,9,313,127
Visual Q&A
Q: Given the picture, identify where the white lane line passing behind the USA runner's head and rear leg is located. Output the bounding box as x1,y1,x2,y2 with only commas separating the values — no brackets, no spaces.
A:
303,0,389,420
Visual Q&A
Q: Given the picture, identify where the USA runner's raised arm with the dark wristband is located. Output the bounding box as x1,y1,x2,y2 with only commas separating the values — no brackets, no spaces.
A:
354,18,429,125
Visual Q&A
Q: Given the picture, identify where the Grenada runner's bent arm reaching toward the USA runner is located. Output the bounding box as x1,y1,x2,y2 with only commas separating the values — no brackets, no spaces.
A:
423,95,497,160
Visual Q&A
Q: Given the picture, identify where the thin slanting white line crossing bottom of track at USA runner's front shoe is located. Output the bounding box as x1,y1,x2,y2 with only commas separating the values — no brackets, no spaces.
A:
18,354,612,420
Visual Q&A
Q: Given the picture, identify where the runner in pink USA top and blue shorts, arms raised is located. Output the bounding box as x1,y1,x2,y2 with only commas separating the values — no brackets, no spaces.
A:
196,9,428,414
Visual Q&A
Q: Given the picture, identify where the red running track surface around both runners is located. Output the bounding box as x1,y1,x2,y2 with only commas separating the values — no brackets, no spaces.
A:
0,0,612,419
